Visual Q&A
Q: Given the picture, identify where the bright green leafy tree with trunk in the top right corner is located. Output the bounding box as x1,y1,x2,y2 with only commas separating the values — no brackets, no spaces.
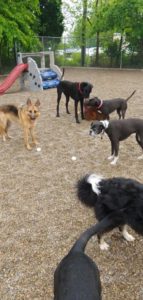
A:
104,0,143,65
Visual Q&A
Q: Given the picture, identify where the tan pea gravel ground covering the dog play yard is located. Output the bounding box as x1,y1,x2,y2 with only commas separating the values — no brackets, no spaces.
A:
0,68,143,300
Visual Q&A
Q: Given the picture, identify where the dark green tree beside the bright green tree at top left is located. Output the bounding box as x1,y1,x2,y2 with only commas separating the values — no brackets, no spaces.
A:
38,0,64,37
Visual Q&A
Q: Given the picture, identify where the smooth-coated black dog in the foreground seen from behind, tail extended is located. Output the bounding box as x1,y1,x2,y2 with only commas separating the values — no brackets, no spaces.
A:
54,218,104,300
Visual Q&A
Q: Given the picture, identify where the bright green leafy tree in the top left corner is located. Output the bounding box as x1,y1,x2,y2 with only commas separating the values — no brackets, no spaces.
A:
0,0,39,69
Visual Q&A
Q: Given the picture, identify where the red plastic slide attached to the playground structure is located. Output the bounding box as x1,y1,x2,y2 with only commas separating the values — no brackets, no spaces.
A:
0,64,28,95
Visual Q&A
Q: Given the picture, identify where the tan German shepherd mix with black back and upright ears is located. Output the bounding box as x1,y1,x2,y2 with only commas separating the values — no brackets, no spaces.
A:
0,98,40,150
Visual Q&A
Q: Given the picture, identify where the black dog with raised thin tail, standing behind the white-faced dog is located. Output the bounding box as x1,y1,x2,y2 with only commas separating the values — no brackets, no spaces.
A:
88,91,136,120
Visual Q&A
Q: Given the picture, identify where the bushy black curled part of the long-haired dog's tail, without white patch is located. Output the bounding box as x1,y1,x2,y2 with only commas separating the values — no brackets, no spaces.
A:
76,175,97,207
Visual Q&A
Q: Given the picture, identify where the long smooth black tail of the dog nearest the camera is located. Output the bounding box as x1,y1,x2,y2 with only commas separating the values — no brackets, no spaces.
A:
70,210,123,252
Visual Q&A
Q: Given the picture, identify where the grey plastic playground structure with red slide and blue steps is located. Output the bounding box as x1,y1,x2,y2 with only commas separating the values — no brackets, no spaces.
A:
0,51,62,95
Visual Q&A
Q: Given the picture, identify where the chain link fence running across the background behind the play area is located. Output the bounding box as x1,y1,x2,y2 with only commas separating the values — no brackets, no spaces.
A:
0,34,143,73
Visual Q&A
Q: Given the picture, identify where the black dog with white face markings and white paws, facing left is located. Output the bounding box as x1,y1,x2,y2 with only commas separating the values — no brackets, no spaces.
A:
89,119,143,165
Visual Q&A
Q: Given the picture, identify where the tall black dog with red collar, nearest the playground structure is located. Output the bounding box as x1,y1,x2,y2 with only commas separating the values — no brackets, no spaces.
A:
57,80,93,123
